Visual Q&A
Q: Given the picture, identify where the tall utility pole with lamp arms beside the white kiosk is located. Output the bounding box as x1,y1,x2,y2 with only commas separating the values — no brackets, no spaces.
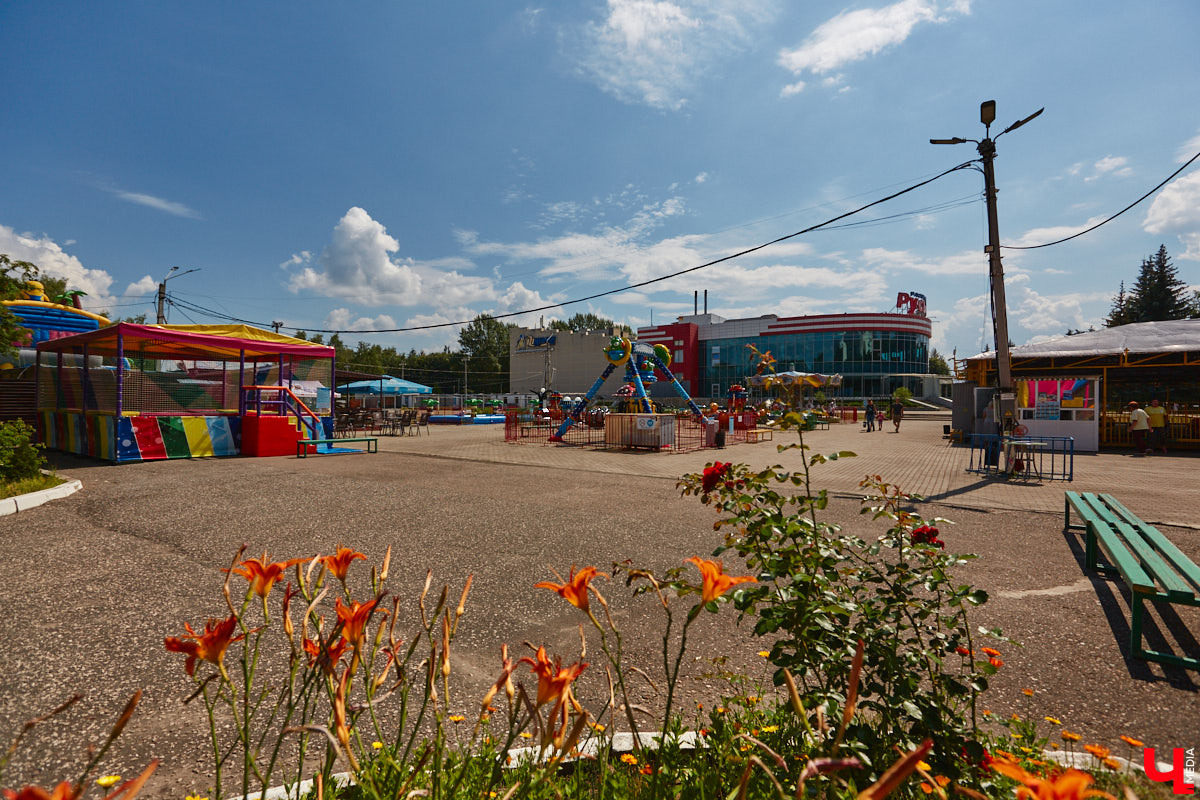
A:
929,100,1045,428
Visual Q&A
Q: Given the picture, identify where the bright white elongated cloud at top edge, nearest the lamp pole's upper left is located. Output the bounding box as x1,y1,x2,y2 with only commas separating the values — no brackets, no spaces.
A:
779,0,971,86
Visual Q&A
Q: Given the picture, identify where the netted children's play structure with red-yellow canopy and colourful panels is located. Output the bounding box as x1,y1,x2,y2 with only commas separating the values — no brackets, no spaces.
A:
36,323,350,463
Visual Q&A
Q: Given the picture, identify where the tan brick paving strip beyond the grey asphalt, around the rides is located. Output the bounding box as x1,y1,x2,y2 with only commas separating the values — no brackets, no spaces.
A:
379,413,1200,527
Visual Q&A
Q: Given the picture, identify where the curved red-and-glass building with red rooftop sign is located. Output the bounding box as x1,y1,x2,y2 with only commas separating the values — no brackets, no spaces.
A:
637,299,937,397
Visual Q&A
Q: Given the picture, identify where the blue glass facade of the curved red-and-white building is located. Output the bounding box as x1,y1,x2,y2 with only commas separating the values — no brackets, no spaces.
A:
700,331,929,397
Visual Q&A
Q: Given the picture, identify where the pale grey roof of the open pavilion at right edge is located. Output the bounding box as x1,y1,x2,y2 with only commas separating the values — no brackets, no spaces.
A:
967,319,1200,361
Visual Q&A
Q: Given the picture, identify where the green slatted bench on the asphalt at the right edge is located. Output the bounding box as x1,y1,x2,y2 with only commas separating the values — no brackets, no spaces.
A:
1063,492,1200,669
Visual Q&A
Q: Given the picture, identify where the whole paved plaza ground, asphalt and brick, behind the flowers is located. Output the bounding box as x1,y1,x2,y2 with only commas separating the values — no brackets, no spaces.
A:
0,415,1200,800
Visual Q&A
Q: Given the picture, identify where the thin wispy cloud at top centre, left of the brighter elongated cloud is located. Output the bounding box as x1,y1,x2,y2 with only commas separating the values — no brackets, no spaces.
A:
571,0,769,110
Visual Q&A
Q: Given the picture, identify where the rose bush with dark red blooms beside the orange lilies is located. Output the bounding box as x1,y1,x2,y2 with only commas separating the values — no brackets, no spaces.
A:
680,414,1003,780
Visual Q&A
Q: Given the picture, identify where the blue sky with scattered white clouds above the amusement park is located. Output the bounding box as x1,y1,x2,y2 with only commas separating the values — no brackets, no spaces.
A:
0,0,1200,356
